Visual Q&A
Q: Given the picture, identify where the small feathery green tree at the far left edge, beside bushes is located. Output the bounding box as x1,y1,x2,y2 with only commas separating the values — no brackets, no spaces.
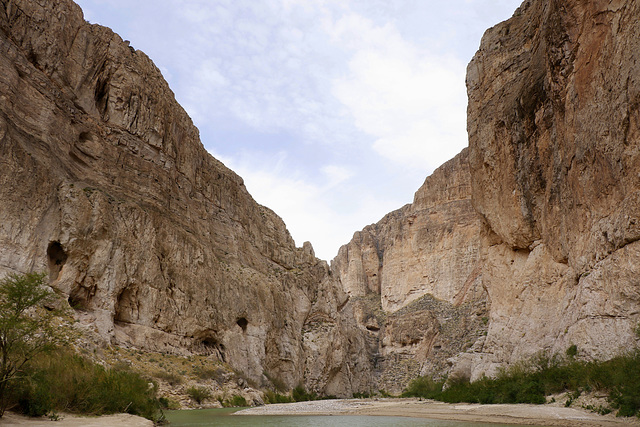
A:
0,273,63,417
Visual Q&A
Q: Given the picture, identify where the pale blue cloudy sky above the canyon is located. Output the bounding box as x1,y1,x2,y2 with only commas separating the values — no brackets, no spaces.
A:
76,0,521,260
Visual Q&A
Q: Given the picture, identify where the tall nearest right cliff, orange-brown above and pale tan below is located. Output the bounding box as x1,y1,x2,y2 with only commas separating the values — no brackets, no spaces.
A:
466,0,640,378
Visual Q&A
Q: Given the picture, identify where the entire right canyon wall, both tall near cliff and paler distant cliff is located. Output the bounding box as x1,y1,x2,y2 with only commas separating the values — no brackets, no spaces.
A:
332,0,640,384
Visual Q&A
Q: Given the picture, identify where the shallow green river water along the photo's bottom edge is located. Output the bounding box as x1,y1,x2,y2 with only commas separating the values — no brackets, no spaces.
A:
165,408,506,427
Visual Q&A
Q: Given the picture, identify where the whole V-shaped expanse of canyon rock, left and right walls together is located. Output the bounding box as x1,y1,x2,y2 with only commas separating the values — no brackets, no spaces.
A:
0,0,640,396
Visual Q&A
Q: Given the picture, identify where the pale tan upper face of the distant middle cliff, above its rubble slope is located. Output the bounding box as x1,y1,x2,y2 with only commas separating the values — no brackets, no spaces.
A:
332,150,480,312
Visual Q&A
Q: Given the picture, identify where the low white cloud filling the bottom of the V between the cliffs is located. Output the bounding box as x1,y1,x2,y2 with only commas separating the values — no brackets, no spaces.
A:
212,152,398,261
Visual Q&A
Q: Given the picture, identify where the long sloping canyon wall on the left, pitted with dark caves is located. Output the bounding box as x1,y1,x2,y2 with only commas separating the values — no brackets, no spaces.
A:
0,0,369,395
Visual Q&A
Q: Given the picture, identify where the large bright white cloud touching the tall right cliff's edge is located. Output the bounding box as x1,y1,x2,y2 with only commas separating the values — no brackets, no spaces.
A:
330,16,467,171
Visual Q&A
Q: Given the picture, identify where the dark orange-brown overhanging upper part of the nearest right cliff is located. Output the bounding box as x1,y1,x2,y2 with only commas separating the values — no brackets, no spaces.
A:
467,1,640,273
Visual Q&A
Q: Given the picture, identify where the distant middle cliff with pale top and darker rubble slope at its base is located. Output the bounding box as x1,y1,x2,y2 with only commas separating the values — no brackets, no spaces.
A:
331,149,487,392
